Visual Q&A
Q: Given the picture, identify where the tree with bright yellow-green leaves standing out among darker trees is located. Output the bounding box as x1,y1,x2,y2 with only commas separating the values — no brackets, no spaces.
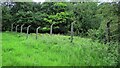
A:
44,2,70,34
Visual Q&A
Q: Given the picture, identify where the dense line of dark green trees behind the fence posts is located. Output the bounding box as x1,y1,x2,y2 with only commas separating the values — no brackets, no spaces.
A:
1,2,120,42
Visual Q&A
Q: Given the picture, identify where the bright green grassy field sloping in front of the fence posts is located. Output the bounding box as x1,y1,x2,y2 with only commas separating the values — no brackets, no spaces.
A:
2,32,117,66
